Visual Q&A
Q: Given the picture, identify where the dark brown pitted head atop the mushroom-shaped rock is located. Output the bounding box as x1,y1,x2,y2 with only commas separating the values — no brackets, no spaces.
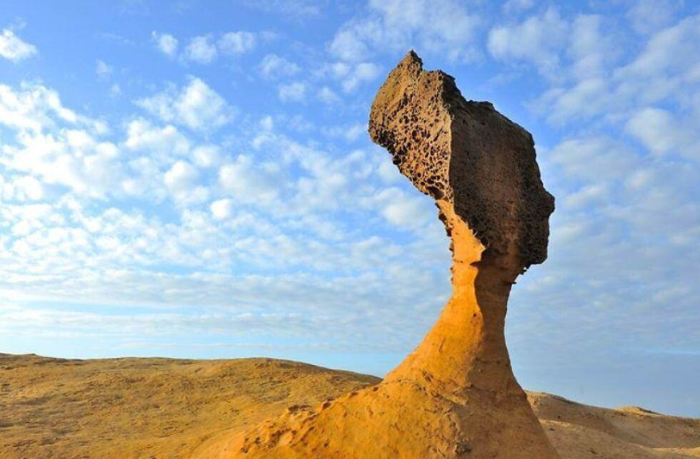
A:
369,51,554,268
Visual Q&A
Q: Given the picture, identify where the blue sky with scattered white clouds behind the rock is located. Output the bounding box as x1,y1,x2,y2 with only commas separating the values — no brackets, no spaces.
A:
0,0,700,416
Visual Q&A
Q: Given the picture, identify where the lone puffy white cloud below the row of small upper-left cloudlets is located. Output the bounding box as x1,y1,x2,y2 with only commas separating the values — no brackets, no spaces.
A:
136,77,233,131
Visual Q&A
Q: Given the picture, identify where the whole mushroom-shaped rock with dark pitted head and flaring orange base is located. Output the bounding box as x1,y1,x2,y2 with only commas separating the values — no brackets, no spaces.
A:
203,51,559,459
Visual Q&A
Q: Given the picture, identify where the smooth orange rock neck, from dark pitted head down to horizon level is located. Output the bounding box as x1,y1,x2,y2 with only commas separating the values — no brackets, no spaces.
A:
385,201,522,396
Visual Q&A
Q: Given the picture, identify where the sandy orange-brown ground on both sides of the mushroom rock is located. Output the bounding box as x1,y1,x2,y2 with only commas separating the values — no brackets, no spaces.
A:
0,354,700,459
